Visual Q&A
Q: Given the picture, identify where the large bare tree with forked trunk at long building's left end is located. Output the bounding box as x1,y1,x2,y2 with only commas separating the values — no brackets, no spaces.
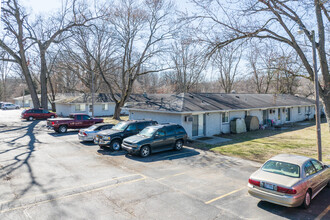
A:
101,0,175,119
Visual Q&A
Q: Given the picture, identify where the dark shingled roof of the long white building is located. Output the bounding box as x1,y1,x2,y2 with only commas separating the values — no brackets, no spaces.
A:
125,93,314,112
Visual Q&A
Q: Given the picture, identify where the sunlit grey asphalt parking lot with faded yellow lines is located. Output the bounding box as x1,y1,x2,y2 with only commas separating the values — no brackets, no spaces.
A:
0,110,330,219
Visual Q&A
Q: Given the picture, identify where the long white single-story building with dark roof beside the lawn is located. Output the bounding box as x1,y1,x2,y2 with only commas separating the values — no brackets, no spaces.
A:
125,93,314,137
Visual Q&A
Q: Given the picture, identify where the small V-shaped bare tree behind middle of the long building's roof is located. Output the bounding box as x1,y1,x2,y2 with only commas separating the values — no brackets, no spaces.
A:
213,45,242,93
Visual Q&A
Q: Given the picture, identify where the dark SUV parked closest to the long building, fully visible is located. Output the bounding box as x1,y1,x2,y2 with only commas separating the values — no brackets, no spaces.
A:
122,124,187,157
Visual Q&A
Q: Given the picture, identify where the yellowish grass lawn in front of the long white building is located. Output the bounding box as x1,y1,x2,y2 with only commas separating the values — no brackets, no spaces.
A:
193,121,330,164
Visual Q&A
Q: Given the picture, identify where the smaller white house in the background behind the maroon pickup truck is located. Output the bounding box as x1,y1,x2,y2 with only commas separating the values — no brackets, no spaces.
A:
55,93,128,116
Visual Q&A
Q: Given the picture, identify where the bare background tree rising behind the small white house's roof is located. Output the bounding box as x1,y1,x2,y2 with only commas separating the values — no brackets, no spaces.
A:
63,23,116,96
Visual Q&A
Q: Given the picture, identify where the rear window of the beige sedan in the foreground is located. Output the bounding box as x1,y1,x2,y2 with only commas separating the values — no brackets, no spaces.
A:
261,160,300,178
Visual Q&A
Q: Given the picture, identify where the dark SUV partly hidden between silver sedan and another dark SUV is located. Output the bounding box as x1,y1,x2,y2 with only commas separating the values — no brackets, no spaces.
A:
94,120,157,151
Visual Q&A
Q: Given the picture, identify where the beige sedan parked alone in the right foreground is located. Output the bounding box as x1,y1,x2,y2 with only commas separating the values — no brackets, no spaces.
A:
248,154,330,208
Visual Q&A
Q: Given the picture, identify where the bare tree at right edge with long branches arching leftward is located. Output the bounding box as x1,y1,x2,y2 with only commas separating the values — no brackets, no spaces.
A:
189,0,330,131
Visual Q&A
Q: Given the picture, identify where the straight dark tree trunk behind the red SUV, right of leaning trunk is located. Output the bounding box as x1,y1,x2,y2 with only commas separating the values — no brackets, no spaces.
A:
40,47,48,110
